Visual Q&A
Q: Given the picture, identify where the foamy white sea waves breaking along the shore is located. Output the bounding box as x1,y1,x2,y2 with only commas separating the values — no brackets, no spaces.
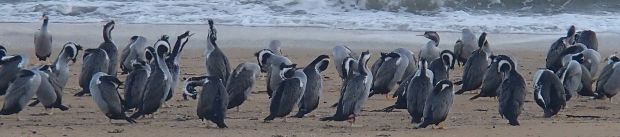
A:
0,0,620,34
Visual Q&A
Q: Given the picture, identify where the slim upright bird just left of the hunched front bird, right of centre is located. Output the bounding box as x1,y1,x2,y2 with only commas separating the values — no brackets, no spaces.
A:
405,59,434,123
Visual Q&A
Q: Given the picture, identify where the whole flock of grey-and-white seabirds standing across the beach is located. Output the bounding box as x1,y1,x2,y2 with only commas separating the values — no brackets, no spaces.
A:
0,15,620,128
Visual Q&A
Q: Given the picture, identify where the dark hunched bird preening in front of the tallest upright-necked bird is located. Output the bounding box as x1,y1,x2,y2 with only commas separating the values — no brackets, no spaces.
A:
196,76,229,128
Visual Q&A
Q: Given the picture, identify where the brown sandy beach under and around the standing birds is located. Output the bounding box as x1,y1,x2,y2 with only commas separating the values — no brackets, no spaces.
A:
0,23,620,137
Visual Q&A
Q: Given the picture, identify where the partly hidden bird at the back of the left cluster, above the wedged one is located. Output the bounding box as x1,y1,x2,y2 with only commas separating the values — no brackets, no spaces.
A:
120,36,146,74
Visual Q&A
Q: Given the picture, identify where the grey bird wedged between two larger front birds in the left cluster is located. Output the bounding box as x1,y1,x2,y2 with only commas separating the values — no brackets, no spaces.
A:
123,59,155,110
